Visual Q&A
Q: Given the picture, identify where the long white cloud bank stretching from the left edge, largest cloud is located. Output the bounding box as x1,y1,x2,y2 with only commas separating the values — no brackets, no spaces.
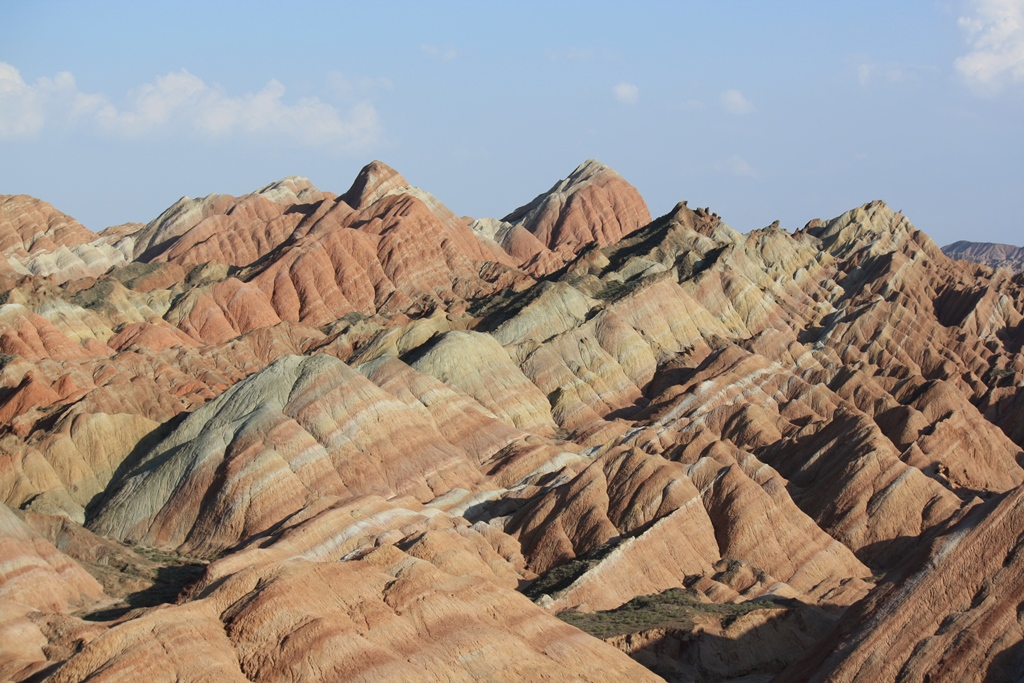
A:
0,62,380,150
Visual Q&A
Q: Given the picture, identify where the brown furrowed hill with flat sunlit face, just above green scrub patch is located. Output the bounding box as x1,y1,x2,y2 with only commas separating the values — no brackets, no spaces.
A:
509,444,870,609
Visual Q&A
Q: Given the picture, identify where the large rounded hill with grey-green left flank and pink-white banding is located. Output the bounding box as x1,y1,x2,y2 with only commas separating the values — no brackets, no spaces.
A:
91,355,478,555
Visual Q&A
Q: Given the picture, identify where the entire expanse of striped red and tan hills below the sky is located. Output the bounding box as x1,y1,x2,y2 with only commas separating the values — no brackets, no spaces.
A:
0,161,1024,682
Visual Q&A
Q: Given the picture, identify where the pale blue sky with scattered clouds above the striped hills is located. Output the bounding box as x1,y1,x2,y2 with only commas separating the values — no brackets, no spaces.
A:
0,0,1024,245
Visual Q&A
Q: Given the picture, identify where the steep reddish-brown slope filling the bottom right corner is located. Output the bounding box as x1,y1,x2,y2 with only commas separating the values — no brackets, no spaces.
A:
778,487,1024,681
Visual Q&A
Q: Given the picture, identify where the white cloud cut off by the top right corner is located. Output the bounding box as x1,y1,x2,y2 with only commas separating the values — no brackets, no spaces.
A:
953,0,1024,90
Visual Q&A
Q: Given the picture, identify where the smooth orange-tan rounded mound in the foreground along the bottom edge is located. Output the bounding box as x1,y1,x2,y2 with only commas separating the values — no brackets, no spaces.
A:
52,549,659,681
